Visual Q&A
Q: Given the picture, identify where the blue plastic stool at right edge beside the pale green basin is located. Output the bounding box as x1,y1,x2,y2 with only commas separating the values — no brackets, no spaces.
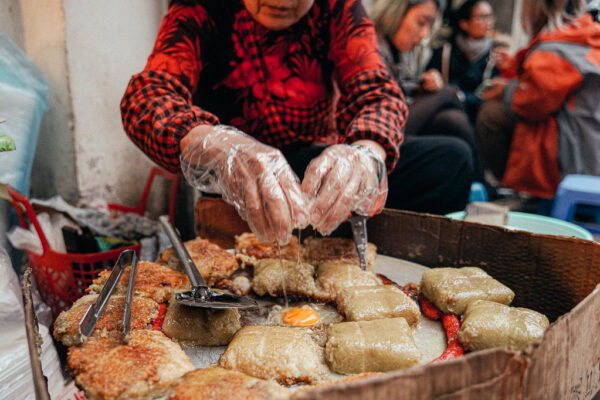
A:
550,175,600,234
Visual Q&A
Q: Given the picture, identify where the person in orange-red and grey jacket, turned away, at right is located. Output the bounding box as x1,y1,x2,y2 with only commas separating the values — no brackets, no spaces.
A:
476,0,600,199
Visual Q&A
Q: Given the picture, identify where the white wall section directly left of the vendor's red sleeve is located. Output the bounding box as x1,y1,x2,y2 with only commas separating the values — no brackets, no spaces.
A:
63,0,166,204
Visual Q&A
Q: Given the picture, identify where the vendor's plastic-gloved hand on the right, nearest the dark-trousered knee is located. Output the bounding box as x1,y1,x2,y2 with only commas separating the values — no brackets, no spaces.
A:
302,144,387,235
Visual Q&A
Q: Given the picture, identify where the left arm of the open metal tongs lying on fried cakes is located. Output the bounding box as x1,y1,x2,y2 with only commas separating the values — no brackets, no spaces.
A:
79,250,137,341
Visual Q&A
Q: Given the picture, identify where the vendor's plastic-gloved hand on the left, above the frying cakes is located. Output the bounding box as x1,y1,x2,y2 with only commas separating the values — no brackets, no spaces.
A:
180,125,308,244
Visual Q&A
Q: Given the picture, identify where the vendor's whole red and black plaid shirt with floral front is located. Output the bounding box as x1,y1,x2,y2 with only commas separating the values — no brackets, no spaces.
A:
121,0,407,171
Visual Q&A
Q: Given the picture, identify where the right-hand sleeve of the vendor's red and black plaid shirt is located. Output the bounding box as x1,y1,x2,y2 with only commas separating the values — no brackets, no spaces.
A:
329,0,408,172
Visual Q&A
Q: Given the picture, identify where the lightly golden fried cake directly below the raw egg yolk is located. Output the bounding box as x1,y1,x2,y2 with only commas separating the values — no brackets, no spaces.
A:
219,326,329,385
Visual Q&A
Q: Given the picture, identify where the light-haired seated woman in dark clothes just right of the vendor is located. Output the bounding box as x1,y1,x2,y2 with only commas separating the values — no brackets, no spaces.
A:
370,0,491,195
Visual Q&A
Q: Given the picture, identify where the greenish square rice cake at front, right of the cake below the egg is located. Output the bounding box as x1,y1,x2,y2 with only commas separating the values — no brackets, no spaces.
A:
325,318,421,374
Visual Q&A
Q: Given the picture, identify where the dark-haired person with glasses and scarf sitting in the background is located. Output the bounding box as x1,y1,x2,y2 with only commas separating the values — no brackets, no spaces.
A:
427,0,506,122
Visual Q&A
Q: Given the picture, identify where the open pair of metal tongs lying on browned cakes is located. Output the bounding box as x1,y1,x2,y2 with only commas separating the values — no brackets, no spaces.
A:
79,250,138,344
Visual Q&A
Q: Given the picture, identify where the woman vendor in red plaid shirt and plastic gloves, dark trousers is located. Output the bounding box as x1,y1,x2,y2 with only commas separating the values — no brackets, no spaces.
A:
121,0,473,243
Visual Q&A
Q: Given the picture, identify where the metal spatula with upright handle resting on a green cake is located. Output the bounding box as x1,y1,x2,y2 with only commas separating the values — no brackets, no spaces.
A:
158,215,258,309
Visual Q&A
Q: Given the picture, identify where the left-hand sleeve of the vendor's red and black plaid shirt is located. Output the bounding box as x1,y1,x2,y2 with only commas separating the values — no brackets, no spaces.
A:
121,4,219,172
